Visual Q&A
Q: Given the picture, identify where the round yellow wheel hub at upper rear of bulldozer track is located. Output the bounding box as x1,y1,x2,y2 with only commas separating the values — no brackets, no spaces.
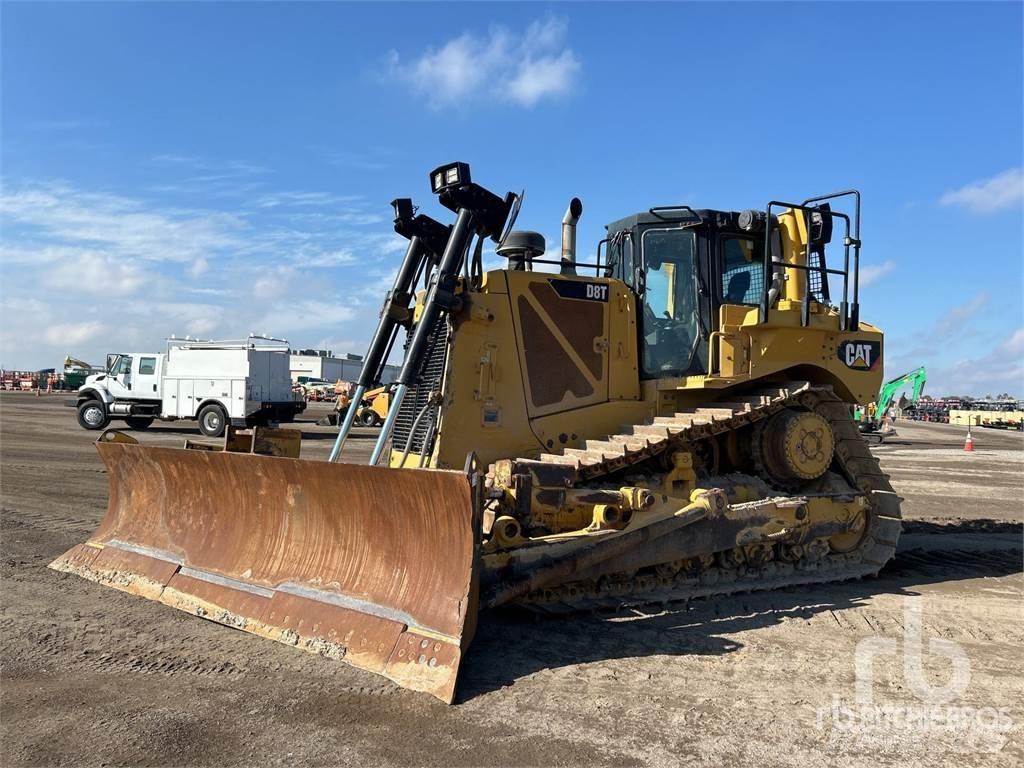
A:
755,408,836,487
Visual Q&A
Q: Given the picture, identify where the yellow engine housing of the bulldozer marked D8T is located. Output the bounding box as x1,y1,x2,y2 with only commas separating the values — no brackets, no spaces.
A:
423,270,652,468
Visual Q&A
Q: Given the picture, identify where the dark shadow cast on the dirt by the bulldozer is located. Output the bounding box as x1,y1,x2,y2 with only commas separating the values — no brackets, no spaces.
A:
459,520,1024,700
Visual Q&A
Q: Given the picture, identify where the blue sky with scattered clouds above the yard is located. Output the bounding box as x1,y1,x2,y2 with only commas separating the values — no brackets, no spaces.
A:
0,2,1024,395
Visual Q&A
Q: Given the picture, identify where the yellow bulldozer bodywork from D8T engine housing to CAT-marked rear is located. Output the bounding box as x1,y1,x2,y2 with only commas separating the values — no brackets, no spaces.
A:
390,234,883,469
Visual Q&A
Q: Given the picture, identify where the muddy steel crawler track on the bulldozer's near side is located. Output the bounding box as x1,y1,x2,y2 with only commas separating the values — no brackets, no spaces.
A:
505,382,901,612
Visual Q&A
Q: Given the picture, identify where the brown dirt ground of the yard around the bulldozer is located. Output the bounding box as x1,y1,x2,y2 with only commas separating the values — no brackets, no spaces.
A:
0,393,1024,768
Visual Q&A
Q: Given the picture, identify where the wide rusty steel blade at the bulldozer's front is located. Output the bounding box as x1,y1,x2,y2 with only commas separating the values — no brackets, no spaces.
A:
50,442,479,701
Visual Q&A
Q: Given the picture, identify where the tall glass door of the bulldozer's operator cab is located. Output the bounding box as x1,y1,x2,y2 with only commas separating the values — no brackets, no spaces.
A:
641,228,698,378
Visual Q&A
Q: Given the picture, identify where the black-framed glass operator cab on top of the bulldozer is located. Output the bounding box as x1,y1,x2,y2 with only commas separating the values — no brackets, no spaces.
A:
604,206,765,379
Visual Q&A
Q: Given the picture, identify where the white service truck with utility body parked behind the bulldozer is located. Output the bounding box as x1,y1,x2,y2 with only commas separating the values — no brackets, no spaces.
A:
67,337,306,437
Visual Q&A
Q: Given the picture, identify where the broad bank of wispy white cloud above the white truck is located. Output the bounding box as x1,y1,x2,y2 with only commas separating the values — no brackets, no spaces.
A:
0,178,415,369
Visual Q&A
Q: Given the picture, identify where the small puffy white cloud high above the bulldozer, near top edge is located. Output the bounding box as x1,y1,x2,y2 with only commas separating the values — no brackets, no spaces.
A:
390,17,582,109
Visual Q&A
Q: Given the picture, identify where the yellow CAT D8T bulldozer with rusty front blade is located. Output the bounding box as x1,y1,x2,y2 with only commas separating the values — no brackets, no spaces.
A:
52,163,900,701
